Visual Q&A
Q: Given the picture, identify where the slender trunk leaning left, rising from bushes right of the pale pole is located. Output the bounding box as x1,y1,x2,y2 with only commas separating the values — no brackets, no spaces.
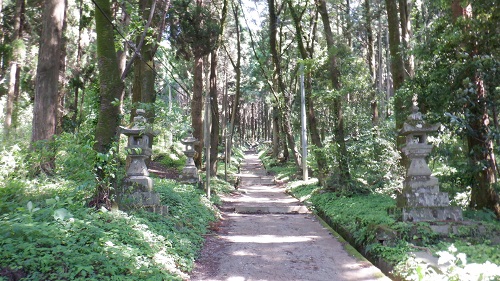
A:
316,0,351,186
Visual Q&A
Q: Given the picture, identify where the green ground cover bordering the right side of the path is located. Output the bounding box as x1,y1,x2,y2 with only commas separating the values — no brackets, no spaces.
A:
288,177,500,280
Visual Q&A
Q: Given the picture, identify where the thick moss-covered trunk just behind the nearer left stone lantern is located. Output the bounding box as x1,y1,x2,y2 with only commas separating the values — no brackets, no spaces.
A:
94,0,124,153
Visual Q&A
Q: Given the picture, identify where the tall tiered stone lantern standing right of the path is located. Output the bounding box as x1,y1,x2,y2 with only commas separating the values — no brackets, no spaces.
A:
397,102,462,222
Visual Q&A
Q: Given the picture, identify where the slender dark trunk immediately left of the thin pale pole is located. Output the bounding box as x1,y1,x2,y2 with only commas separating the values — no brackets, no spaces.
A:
268,0,302,170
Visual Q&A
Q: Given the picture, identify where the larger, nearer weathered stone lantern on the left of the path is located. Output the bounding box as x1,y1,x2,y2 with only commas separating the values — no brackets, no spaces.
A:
117,109,162,212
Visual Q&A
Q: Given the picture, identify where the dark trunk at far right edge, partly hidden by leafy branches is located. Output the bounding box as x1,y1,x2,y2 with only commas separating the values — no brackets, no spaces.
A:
451,0,500,214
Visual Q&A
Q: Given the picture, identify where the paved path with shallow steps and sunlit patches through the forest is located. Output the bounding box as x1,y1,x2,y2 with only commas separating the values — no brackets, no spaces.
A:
191,152,390,281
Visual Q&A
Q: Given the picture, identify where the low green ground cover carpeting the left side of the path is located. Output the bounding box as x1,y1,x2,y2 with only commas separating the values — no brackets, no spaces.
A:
0,177,216,280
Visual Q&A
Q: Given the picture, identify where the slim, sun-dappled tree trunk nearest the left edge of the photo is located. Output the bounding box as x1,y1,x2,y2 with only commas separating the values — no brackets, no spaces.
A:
3,0,24,140
